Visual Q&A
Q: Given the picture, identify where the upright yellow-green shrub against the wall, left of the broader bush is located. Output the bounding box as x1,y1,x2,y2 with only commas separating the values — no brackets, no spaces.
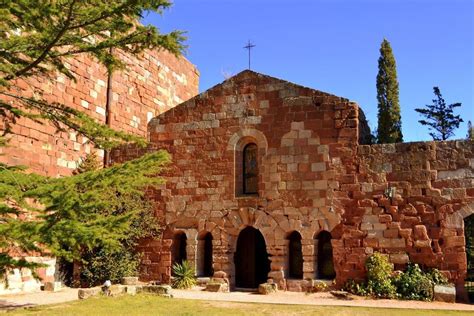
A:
365,253,396,298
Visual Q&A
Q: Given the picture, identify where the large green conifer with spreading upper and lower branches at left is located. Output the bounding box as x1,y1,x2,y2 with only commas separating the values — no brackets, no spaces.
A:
0,0,184,282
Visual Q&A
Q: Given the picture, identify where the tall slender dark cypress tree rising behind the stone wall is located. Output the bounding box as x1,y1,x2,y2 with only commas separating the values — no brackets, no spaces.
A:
377,39,403,144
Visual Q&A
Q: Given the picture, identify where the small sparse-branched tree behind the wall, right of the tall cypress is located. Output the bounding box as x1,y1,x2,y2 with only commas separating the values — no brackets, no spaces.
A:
415,87,463,140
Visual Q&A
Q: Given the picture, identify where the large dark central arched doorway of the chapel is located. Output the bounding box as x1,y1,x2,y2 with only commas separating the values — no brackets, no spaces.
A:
234,226,270,288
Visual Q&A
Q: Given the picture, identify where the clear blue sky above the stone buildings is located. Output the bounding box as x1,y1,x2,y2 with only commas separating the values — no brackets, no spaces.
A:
143,0,474,141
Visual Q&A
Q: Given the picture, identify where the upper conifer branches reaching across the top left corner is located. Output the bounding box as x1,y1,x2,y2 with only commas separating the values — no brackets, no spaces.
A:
0,0,184,149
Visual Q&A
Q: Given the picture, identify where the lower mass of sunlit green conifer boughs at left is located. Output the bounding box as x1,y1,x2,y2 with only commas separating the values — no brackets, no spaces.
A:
0,151,170,278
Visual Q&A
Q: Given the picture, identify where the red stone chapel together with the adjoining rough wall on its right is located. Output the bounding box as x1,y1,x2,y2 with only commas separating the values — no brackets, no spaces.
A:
111,70,474,294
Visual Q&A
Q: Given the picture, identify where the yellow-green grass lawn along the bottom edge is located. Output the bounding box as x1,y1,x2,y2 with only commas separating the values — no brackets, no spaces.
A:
5,294,473,316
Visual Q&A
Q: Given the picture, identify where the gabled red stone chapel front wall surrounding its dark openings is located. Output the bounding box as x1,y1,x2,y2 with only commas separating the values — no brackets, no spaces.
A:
112,71,358,290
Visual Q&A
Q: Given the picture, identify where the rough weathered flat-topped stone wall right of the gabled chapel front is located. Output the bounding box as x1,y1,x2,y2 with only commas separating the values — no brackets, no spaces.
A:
333,141,474,293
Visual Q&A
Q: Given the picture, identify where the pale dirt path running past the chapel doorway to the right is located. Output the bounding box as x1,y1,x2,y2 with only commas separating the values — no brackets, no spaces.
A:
172,287,474,312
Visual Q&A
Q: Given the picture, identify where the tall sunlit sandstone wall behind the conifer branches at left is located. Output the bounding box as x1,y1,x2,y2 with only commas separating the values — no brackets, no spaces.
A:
0,50,199,176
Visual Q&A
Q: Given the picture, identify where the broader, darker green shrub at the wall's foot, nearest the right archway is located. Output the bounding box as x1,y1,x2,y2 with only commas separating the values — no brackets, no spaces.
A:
393,264,434,301
